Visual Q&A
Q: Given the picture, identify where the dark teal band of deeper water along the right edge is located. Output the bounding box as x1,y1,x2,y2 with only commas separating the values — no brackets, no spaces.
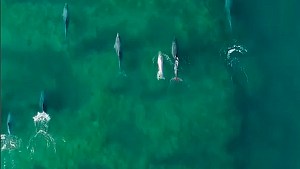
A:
228,1,300,169
